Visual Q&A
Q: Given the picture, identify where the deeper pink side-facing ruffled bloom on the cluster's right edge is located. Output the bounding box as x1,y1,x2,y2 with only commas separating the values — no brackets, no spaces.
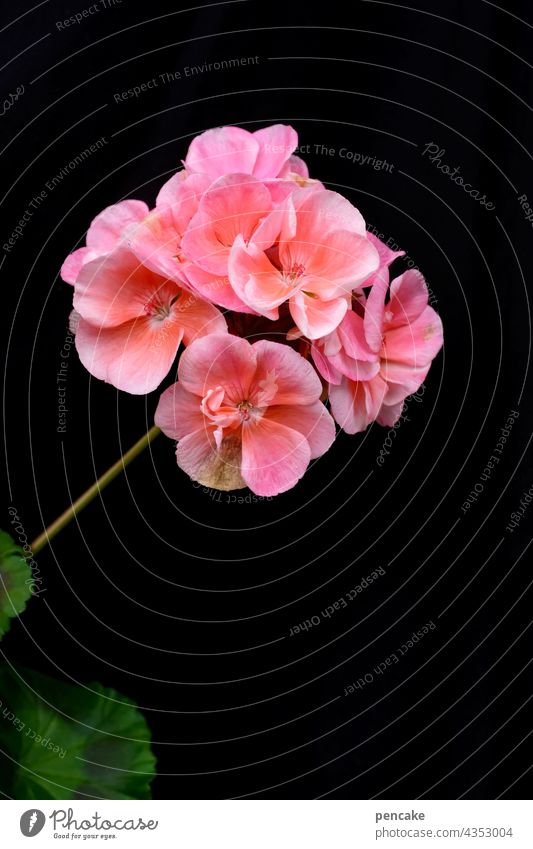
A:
312,270,443,433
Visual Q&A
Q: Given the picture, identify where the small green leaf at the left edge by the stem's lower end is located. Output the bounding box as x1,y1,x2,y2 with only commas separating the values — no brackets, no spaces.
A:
0,531,32,640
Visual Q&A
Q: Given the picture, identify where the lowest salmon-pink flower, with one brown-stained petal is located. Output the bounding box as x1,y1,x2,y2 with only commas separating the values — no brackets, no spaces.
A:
155,334,335,496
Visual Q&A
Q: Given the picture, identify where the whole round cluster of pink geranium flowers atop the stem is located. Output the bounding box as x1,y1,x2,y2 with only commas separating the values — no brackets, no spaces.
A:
61,124,442,496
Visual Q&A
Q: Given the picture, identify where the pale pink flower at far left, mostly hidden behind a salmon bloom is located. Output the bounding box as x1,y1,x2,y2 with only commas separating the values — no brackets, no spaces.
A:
60,200,148,284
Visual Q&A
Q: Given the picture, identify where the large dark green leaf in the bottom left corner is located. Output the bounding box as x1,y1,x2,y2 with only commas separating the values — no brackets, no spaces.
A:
0,665,155,799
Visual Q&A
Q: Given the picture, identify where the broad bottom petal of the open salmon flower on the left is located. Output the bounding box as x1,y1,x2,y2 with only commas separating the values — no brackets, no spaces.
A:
76,316,183,395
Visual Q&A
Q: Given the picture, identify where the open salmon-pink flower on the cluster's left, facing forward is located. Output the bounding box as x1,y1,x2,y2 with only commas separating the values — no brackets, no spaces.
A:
74,244,226,395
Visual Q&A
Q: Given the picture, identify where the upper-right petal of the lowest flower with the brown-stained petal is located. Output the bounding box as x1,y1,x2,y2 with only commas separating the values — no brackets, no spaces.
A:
250,339,322,407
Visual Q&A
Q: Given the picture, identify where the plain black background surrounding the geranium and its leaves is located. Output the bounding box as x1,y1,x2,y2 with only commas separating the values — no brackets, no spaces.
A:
0,0,533,799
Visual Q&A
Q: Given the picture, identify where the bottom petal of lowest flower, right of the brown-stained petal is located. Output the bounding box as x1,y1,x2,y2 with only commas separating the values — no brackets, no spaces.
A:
242,416,311,496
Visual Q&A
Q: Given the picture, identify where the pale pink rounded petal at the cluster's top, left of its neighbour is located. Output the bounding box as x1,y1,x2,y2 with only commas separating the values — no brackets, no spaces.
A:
185,127,258,177
